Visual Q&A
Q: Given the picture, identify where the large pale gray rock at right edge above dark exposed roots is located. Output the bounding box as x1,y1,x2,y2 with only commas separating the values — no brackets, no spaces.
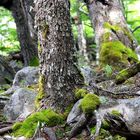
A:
98,97,140,135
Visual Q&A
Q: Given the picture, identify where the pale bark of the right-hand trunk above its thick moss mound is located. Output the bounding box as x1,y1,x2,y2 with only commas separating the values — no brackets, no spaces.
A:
85,0,137,67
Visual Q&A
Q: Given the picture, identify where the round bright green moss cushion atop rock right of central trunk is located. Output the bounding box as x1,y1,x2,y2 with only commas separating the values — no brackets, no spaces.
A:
79,94,100,114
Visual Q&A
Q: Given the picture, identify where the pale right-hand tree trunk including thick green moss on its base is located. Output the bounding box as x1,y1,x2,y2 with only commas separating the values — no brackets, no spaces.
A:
85,0,137,67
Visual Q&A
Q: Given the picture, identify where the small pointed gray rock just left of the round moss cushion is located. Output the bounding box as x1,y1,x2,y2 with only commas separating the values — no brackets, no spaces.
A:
67,100,82,125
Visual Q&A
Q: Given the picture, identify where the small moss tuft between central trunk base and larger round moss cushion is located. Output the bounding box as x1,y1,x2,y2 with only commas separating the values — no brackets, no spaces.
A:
75,88,88,99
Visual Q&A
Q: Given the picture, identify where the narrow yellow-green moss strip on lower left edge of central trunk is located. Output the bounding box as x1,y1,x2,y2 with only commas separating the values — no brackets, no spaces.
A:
35,75,45,107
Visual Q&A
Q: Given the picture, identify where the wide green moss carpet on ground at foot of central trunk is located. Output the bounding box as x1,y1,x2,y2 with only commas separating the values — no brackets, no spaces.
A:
13,109,63,138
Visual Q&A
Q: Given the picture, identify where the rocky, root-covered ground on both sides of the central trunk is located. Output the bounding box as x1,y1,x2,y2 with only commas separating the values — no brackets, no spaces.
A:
0,57,140,140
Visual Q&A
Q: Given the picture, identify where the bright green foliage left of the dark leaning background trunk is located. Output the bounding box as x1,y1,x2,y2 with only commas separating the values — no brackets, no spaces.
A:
0,7,19,55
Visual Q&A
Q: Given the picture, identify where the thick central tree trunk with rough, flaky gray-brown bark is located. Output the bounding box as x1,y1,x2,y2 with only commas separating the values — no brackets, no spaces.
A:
35,0,83,111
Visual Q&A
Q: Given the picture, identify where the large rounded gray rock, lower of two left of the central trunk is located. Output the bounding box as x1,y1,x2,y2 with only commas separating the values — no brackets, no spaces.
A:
4,88,37,121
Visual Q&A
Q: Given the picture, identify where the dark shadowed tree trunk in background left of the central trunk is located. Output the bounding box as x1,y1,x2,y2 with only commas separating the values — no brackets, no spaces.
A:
0,0,38,66
